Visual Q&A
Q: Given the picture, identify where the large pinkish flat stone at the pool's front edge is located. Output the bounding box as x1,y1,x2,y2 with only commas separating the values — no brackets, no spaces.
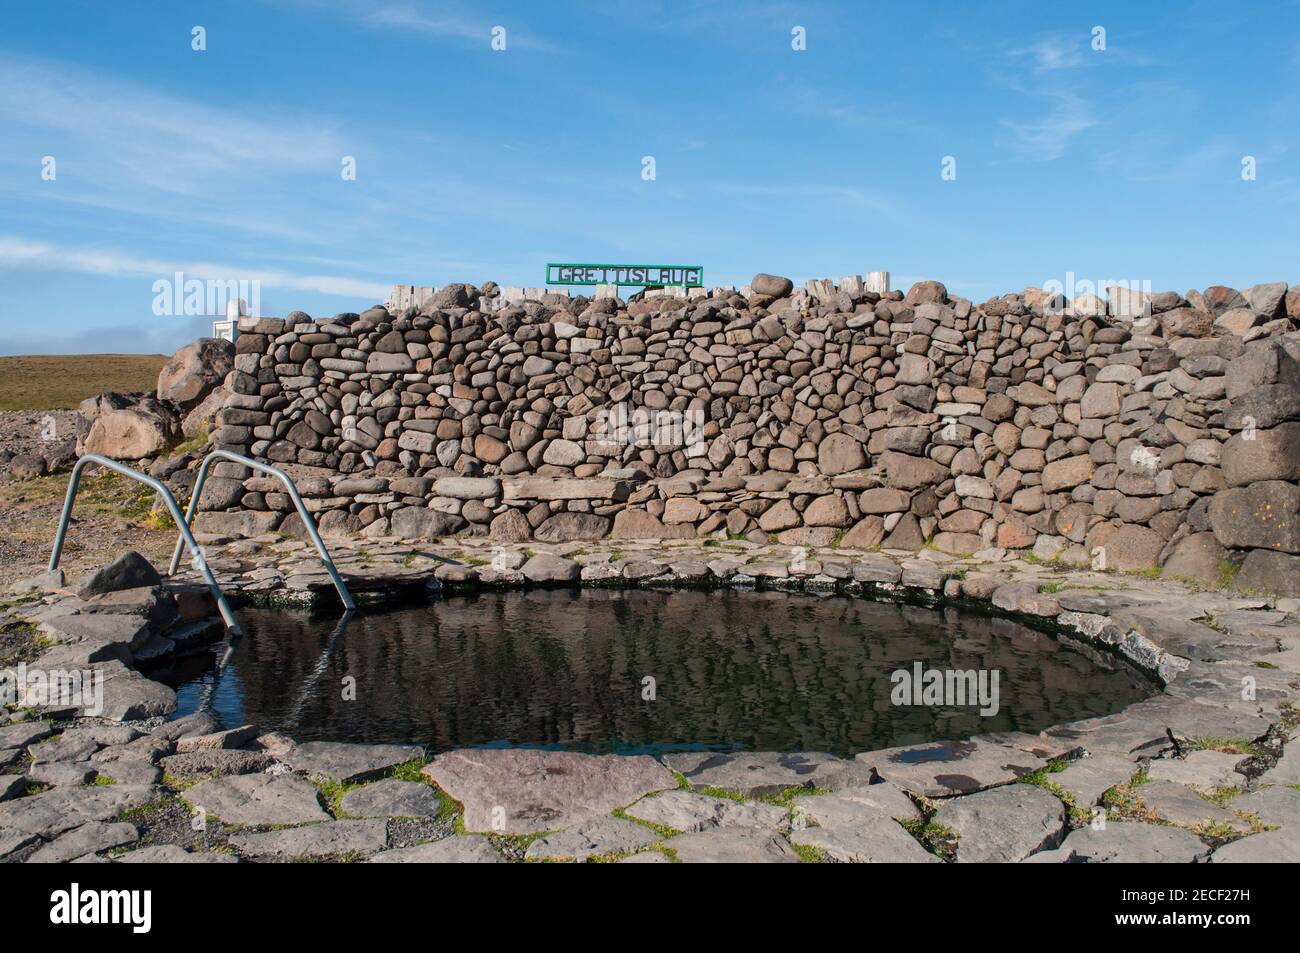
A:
424,748,677,833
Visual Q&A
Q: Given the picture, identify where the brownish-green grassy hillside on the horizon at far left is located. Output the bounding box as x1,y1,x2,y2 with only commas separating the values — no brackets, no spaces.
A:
0,354,168,411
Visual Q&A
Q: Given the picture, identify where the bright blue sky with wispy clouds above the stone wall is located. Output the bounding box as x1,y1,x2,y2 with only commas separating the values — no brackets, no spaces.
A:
0,0,1300,354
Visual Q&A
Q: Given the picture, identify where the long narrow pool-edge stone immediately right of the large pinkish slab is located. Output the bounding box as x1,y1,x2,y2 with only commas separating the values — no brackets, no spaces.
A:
663,751,871,796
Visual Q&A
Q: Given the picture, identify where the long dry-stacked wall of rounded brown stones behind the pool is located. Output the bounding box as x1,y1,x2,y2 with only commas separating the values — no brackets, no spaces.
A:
199,274,1300,594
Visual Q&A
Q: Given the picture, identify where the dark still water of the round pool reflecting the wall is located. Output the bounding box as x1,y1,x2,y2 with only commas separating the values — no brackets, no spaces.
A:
153,590,1152,755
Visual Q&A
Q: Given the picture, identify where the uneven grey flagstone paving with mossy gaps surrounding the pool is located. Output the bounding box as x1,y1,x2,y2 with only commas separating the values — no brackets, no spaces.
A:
0,536,1300,863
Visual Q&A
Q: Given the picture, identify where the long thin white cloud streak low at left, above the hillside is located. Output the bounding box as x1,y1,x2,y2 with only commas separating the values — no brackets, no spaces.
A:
0,235,391,302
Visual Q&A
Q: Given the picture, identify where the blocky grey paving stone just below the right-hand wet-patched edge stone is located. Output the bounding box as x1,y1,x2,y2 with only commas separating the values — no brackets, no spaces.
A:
935,784,1065,863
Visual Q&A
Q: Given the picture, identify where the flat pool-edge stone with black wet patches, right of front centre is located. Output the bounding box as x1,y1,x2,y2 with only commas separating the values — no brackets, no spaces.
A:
858,738,1058,797
